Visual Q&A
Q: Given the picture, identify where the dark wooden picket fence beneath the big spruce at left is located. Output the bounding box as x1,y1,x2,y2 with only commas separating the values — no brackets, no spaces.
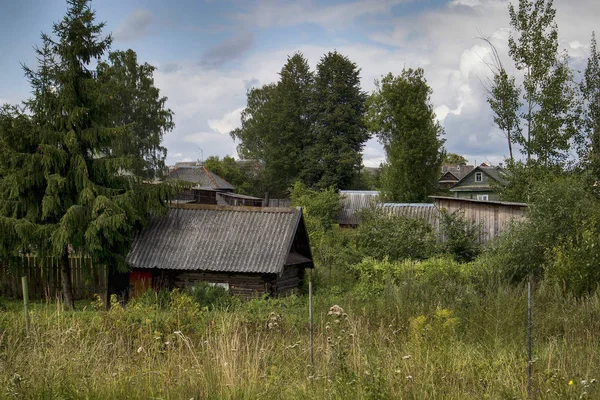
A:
0,255,108,299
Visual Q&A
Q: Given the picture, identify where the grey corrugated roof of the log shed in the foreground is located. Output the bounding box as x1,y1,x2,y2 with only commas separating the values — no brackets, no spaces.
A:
127,206,302,274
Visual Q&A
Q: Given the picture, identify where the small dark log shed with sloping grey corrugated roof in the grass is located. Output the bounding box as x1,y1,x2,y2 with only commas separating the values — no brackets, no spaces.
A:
122,204,314,297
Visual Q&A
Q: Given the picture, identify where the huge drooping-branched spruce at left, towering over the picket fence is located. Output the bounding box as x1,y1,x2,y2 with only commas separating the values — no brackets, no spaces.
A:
0,0,171,308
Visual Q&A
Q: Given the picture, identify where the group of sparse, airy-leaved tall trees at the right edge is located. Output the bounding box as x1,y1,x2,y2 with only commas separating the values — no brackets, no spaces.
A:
484,0,600,201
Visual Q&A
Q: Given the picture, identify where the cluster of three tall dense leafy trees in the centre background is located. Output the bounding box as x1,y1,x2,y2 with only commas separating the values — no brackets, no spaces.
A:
230,51,444,202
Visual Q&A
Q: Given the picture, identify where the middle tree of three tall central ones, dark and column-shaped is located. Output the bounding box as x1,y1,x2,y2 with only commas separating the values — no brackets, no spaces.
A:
302,51,369,189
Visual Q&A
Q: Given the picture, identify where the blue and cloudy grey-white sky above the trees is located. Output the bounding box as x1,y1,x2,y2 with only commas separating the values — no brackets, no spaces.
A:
0,0,600,167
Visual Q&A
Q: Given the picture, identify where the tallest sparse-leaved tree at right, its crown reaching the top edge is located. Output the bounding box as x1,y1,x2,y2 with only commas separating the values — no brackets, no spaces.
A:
505,0,578,166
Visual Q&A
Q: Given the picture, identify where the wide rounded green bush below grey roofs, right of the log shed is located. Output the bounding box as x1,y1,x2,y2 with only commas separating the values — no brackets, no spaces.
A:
357,207,438,261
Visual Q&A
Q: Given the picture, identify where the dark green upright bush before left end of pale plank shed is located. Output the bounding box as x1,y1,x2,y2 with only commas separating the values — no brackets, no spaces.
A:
440,209,481,262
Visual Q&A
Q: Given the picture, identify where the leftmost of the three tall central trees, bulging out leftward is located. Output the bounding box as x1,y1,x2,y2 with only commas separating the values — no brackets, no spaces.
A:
231,53,313,195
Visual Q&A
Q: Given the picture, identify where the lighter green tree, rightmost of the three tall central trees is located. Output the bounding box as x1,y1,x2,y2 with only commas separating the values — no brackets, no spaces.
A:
366,69,444,202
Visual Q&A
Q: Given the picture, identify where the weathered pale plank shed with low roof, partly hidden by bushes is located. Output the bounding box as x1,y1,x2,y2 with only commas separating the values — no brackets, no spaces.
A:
430,196,527,243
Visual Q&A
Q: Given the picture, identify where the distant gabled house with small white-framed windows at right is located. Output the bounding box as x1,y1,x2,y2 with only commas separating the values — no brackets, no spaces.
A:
450,165,506,200
